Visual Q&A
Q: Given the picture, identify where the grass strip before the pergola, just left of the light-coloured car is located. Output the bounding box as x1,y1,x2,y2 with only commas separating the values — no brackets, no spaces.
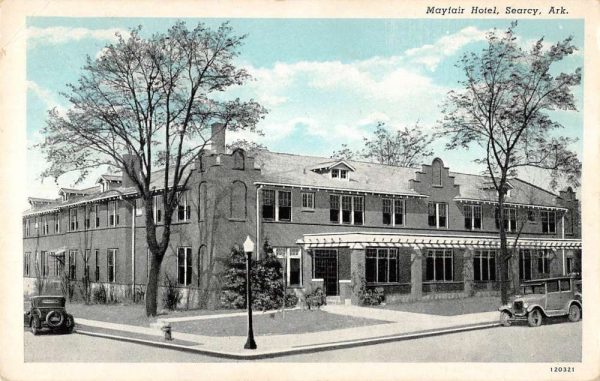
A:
379,296,500,316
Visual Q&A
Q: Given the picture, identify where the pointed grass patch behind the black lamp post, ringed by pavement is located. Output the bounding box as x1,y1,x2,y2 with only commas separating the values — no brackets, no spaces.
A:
172,310,388,336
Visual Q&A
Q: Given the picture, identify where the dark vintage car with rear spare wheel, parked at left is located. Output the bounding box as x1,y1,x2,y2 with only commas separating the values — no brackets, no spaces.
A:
23,296,75,335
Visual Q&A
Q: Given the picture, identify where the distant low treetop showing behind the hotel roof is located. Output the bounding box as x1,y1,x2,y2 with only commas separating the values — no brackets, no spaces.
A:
332,122,435,167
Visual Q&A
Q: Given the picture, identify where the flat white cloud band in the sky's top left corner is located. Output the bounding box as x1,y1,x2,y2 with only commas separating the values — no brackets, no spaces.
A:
27,26,129,44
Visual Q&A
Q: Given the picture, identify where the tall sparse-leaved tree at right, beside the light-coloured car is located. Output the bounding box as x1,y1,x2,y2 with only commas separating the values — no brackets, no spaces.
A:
440,23,581,302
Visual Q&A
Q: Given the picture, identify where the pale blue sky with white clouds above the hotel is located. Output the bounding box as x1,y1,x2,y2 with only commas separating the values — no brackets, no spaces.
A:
27,17,585,202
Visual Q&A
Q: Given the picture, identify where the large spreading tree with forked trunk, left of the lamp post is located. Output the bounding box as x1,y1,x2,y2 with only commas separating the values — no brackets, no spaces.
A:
39,22,266,316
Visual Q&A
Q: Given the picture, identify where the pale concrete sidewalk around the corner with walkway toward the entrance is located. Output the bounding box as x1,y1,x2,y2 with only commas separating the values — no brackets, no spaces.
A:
75,305,498,359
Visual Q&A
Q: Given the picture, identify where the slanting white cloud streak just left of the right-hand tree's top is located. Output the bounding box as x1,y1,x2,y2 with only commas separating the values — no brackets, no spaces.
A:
404,26,487,71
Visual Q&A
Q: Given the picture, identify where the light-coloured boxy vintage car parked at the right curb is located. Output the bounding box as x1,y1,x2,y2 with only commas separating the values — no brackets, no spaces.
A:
498,276,583,327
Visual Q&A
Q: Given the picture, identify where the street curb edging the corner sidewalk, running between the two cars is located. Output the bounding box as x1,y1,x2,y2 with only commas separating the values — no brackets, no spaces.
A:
75,322,500,360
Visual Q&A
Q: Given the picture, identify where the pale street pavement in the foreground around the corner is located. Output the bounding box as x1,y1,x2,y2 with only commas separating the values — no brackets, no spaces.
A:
25,322,582,363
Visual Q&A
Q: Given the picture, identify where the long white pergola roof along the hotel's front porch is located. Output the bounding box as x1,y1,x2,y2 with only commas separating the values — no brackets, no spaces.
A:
296,233,581,249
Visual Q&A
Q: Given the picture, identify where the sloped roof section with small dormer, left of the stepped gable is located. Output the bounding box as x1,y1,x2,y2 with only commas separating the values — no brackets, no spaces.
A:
254,150,421,196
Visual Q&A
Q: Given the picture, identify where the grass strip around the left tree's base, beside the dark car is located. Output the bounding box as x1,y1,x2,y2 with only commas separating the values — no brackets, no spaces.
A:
66,303,244,327
